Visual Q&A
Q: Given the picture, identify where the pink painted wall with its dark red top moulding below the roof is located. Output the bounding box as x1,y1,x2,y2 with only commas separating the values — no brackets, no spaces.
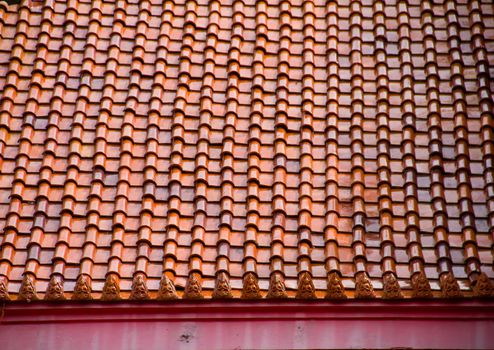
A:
0,301,494,350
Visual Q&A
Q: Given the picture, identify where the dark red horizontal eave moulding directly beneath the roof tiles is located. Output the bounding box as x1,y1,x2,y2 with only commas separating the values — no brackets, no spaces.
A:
2,299,494,324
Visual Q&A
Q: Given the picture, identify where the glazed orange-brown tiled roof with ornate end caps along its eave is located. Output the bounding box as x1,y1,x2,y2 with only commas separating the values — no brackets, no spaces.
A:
0,0,494,300
